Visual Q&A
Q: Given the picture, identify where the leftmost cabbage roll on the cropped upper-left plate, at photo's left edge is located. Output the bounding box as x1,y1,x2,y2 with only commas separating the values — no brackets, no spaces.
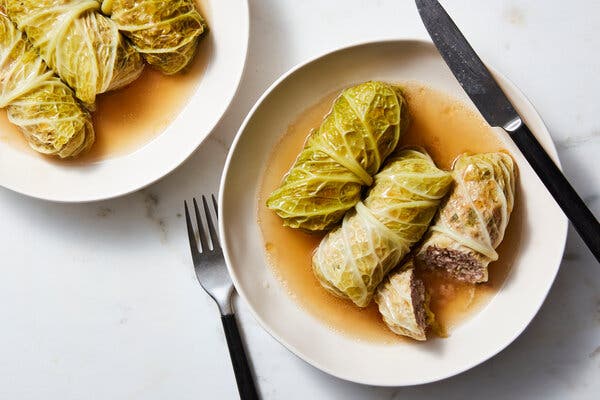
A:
0,13,94,157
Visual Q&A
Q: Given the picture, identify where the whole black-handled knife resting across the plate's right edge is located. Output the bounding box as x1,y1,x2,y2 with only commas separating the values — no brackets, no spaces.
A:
416,0,600,262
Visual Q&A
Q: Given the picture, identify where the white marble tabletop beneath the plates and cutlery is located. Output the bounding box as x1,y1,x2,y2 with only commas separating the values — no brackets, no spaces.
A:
0,0,600,400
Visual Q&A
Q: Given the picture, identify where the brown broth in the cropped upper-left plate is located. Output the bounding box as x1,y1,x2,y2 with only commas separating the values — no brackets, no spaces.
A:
0,1,211,163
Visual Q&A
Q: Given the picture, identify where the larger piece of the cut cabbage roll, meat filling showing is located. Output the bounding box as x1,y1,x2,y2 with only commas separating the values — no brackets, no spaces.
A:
417,153,515,283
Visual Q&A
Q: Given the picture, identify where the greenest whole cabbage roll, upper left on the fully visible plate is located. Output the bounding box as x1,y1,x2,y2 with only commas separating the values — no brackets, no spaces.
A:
267,82,407,231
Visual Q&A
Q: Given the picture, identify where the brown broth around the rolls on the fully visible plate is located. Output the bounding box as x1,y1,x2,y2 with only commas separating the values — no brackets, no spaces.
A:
258,83,522,343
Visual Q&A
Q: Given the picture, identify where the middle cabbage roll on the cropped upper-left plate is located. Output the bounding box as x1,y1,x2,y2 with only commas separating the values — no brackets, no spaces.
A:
3,0,144,106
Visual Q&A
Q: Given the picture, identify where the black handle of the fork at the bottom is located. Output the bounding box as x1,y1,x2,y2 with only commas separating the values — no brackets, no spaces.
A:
221,314,258,400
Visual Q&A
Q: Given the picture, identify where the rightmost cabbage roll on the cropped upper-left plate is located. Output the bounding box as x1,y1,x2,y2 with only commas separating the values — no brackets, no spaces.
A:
102,0,208,75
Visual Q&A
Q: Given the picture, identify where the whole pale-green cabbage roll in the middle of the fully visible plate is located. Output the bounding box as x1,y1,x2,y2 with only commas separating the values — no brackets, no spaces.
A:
312,150,452,307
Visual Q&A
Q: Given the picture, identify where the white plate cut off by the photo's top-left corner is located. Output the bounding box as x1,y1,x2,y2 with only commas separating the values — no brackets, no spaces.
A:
0,0,249,202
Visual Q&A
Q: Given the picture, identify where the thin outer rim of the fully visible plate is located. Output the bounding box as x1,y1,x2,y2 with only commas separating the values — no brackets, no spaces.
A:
218,37,569,387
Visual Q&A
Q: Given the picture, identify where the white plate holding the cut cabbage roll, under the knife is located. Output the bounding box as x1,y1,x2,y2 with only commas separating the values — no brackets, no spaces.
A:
219,40,567,386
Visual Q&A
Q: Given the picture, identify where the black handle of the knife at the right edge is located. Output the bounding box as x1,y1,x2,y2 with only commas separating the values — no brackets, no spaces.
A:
509,123,600,262
